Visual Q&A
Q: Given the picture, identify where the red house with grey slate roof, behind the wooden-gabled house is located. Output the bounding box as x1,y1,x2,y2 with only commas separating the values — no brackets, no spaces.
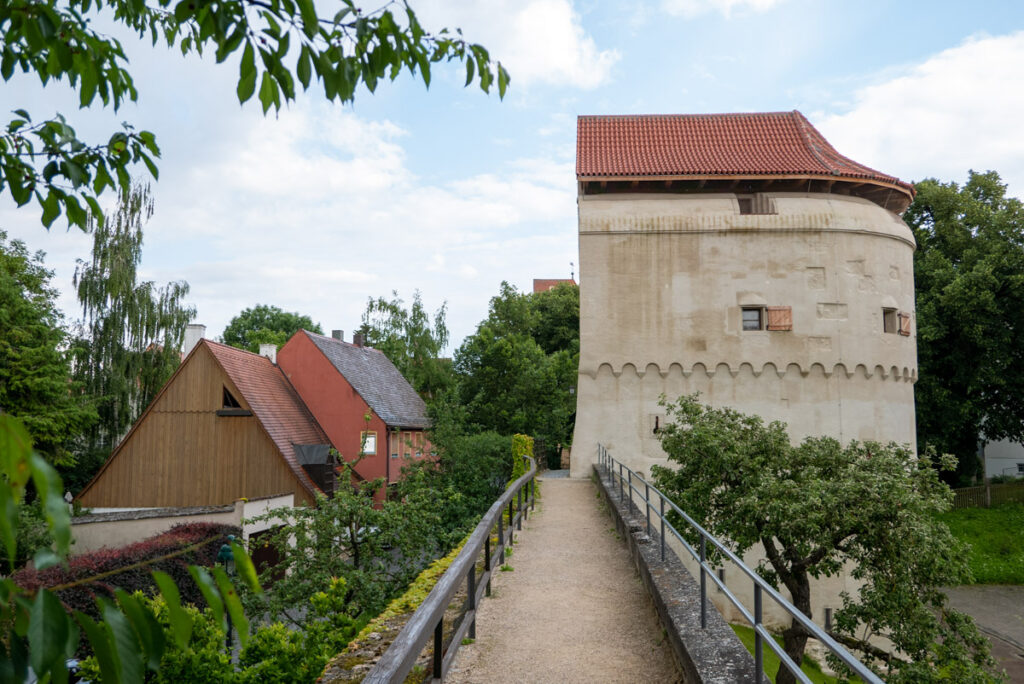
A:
278,331,430,483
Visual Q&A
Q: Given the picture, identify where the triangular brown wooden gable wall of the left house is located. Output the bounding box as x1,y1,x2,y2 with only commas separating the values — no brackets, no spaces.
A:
78,346,312,508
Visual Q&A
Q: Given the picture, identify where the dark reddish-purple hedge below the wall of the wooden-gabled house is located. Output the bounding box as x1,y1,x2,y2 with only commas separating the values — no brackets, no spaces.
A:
12,522,242,618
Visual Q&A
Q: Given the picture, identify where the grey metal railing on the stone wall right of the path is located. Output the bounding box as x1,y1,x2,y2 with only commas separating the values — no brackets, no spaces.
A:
597,444,883,684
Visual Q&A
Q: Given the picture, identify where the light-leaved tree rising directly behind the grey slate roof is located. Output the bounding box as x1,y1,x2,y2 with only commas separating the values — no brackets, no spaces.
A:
358,290,454,399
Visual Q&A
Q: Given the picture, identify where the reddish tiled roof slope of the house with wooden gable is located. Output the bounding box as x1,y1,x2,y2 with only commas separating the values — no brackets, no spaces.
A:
207,340,331,494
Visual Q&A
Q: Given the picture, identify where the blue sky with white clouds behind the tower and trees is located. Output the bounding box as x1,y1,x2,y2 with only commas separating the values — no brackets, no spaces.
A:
0,0,1024,352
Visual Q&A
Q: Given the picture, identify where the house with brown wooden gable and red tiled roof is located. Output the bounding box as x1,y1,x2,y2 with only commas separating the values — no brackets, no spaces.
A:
78,340,335,509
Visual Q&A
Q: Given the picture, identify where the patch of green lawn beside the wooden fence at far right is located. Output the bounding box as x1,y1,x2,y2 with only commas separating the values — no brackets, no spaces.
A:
939,504,1024,585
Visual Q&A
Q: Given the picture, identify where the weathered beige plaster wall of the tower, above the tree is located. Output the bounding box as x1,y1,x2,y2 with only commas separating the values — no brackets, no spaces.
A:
571,189,916,477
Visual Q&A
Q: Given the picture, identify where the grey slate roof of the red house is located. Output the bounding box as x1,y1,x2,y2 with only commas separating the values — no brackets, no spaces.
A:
300,331,430,428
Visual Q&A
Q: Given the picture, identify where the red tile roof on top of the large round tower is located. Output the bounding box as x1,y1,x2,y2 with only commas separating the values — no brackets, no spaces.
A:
577,111,913,194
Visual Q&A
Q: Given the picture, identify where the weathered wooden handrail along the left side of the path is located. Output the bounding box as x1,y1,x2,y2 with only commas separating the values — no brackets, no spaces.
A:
362,456,537,684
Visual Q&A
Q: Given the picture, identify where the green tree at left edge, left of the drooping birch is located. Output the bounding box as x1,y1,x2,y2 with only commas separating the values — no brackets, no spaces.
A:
0,230,95,465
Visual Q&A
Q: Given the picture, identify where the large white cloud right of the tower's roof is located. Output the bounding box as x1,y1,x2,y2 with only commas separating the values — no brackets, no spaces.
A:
815,32,1024,195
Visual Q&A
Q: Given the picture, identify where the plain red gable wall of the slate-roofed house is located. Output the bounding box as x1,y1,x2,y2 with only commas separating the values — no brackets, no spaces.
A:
278,334,390,480
